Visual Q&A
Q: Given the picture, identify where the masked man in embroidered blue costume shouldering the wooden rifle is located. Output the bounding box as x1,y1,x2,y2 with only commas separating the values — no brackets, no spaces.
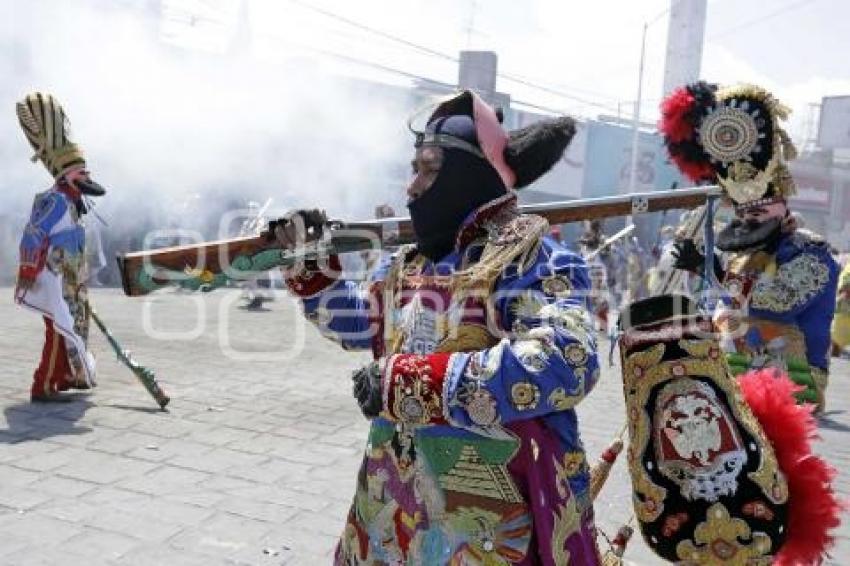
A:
279,91,599,565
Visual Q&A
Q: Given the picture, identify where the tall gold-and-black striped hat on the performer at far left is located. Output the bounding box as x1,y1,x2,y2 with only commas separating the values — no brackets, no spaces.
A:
16,92,86,179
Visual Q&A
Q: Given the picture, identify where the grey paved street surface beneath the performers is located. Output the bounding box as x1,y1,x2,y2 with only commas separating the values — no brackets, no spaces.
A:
0,289,850,566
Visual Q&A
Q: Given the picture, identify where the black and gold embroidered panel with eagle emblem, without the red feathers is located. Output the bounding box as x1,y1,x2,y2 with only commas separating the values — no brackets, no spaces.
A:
621,320,788,565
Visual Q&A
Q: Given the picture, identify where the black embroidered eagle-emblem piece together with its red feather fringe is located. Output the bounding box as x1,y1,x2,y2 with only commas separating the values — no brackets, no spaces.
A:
619,295,841,566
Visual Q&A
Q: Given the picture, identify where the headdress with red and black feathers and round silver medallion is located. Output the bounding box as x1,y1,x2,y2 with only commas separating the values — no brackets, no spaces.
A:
658,81,797,205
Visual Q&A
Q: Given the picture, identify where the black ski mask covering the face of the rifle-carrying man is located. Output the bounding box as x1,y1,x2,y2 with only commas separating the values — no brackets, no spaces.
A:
407,116,507,261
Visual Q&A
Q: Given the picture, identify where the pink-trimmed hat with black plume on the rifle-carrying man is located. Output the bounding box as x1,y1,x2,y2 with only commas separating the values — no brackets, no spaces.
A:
408,90,576,189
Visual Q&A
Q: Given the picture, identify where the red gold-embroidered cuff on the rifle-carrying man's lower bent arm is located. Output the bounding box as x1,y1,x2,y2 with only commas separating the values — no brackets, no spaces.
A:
381,353,451,425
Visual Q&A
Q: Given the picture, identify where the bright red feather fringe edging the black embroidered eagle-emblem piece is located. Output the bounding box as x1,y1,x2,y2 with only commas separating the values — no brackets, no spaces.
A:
738,370,844,566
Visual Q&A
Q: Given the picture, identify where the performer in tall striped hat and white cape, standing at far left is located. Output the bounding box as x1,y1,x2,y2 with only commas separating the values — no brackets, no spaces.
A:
15,92,105,402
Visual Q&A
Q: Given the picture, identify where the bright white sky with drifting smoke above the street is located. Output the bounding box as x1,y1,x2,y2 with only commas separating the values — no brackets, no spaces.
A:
0,0,850,224
